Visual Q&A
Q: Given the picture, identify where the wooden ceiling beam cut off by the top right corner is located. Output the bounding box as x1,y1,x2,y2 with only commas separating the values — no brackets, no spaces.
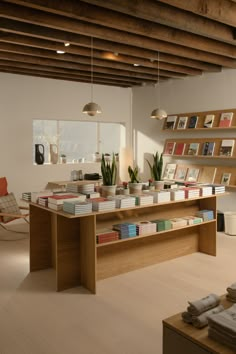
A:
159,0,236,27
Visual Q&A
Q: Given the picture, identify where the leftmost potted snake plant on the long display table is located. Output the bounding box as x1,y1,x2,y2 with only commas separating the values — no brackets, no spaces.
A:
101,153,117,197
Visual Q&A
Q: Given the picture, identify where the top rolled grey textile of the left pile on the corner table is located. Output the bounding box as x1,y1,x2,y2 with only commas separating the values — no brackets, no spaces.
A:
187,294,220,316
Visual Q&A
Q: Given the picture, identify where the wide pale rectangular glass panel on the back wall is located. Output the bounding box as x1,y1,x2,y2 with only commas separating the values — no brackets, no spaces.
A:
32,119,126,164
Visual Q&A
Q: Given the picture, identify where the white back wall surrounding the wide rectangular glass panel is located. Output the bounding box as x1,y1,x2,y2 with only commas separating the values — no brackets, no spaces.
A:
0,73,132,198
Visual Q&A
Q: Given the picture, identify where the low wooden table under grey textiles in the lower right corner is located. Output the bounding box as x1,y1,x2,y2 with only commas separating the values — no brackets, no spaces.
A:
163,296,235,354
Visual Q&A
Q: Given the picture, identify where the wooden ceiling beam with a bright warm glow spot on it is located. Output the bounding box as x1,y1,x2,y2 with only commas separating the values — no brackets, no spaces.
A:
0,33,202,75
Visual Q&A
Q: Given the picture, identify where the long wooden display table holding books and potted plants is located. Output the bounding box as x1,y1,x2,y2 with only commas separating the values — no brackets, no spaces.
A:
30,195,216,293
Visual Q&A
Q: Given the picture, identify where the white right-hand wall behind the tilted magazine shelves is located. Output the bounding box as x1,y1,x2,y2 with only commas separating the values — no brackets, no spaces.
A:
133,69,236,210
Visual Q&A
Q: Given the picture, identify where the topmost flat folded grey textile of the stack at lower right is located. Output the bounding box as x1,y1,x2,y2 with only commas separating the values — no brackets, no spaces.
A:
208,304,236,341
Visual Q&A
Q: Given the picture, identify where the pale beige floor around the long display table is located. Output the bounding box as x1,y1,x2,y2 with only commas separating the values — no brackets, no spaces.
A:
0,225,236,354
